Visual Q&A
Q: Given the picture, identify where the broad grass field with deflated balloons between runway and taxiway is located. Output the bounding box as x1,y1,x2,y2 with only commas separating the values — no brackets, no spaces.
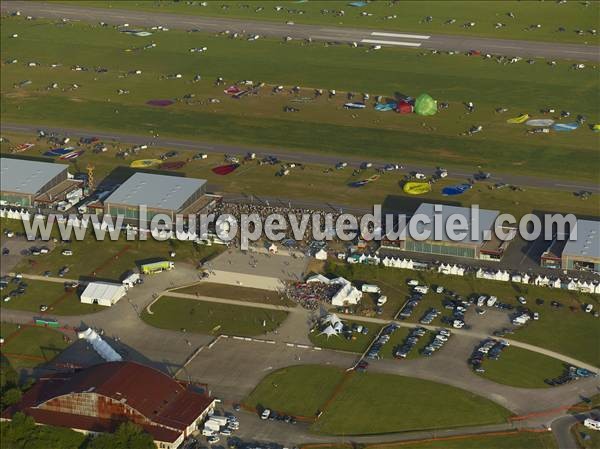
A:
1,18,600,181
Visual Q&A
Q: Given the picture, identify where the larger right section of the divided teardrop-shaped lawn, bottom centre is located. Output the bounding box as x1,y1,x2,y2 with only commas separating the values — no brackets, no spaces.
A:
312,373,510,435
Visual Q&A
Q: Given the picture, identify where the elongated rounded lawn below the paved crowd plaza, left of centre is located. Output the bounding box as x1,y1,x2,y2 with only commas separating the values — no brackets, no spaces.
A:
142,296,287,337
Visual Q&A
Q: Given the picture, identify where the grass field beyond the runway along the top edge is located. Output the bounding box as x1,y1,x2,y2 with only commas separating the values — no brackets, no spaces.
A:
59,0,599,43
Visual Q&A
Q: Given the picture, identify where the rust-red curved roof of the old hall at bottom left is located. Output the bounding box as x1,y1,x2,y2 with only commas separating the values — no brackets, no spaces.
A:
2,362,214,441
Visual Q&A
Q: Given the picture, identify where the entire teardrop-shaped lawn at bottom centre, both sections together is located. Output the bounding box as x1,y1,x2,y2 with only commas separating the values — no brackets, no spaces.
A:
248,365,509,435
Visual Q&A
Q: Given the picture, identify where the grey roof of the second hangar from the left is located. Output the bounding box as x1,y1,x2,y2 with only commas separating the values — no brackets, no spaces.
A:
106,173,206,211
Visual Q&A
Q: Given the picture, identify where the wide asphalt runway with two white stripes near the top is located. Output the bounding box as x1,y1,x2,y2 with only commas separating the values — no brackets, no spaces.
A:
1,1,600,61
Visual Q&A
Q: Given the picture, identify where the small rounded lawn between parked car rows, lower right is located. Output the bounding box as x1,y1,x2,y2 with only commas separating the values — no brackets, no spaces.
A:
481,347,565,388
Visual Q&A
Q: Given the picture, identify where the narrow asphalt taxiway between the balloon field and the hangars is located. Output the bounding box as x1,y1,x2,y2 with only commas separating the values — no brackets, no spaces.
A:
0,122,600,194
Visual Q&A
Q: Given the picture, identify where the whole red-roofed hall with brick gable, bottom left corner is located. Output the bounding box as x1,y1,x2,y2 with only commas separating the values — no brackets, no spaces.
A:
2,362,215,449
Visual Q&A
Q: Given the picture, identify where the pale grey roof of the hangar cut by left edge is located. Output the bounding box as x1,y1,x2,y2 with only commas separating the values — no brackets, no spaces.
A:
0,157,69,195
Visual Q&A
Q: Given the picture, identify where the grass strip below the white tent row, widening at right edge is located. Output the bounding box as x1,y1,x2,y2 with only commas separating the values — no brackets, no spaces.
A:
326,263,600,366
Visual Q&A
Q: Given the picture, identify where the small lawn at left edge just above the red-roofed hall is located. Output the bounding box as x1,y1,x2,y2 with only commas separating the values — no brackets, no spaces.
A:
2,323,69,372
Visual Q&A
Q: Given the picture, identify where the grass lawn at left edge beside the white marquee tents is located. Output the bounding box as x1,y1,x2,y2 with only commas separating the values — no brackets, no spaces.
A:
0,279,104,315
